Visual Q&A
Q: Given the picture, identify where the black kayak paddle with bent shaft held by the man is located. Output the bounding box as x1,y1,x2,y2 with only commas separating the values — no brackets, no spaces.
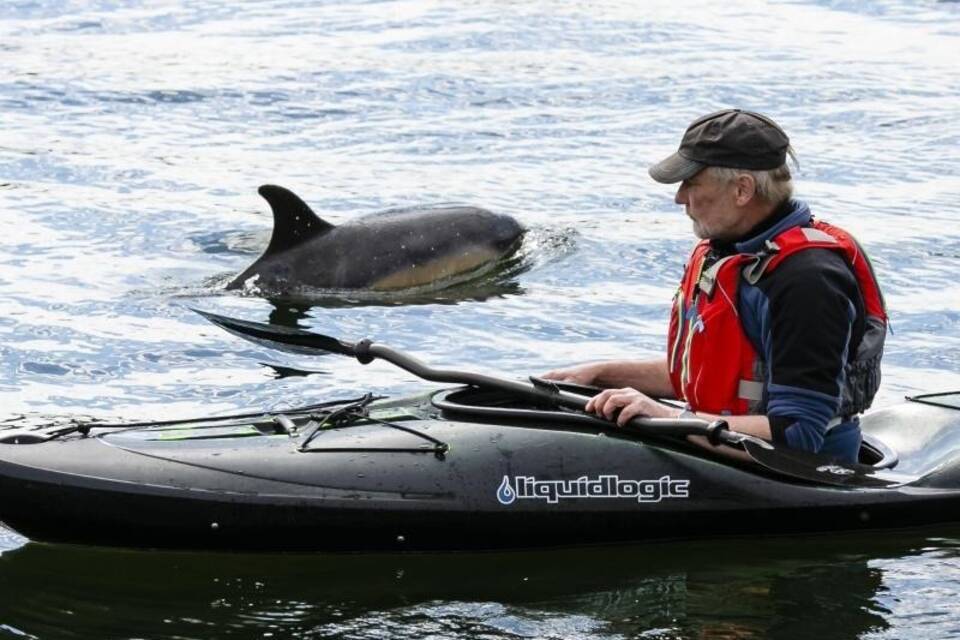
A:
193,309,914,488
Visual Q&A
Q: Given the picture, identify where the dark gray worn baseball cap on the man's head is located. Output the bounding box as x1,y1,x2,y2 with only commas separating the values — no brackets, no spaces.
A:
649,109,790,184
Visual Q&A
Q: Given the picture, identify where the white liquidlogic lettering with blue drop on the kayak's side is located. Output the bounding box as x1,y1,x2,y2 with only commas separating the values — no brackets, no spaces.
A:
497,475,690,504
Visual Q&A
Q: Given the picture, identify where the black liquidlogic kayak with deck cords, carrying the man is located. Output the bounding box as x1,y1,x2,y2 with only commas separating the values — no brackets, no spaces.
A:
0,385,960,551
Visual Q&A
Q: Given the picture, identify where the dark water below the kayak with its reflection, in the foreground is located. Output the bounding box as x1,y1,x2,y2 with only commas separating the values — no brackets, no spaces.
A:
0,536,960,638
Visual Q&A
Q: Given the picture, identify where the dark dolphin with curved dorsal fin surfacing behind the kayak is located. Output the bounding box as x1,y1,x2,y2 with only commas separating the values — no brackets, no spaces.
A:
227,185,525,294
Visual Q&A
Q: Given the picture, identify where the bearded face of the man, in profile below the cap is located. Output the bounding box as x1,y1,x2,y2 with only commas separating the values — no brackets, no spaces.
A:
674,170,743,240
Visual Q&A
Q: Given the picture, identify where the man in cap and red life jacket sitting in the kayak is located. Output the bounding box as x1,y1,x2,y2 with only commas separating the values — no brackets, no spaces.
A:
546,109,887,462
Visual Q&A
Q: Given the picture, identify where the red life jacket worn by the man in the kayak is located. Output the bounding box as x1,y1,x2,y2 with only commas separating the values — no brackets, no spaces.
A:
667,222,887,416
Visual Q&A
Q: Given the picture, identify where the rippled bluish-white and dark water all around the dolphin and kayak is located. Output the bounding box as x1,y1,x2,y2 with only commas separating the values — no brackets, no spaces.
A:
0,0,960,639
